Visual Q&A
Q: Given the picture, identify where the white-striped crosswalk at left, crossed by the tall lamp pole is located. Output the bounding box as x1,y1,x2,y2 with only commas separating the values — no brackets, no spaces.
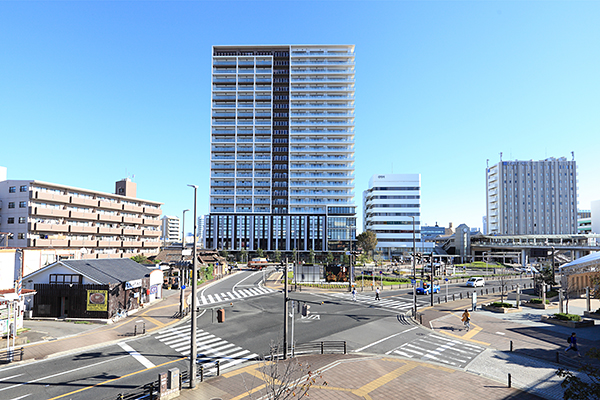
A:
154,325,258,373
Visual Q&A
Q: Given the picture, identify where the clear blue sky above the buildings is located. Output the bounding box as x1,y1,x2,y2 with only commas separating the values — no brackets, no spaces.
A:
0,1,600,231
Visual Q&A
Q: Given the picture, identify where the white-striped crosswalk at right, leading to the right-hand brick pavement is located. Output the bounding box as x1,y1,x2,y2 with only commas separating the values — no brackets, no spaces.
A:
387,333,485,368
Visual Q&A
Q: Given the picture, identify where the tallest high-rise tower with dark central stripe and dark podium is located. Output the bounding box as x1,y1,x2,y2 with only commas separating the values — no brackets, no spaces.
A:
204,45,356,251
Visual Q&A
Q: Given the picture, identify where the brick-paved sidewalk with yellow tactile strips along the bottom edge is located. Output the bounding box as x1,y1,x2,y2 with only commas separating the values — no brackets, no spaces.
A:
179,355,541,400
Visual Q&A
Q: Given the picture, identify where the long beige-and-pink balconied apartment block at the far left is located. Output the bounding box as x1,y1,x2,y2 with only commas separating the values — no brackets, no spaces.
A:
0,175,162,262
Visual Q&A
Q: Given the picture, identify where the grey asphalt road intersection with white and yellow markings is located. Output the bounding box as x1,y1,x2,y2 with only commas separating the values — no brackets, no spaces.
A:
0,271,536,400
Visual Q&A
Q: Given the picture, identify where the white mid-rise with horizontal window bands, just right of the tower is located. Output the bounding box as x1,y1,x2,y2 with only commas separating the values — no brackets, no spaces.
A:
363,174,422,259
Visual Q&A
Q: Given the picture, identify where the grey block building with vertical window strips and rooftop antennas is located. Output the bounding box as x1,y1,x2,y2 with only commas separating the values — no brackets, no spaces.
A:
486,157,577,235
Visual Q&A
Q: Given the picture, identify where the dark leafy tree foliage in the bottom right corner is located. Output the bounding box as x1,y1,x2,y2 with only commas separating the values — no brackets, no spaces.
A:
556,348,600,400
